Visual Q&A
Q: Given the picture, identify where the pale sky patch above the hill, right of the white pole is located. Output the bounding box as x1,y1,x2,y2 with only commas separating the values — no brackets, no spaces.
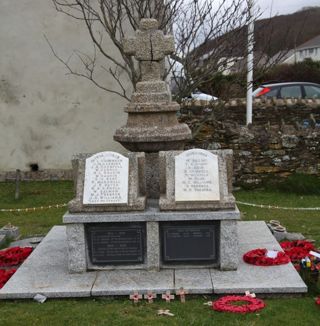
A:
255,0,320,17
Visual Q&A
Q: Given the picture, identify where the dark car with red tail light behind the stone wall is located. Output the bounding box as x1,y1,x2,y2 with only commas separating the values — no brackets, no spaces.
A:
252,82,320,99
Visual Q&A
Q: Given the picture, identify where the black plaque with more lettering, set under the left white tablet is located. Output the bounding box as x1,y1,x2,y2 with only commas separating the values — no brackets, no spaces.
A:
86,223,145,265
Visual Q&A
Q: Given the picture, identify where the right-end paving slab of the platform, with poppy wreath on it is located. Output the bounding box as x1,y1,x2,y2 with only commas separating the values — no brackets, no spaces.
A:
210,221,307,293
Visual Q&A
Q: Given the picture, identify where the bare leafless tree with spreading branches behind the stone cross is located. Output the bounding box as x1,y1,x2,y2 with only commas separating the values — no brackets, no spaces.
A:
47,0,290,100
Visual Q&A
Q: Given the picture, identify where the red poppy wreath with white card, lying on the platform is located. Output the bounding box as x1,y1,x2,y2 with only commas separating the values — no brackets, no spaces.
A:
243,248,290,266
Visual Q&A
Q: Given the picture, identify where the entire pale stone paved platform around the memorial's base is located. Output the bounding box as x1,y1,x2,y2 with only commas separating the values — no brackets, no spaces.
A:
0,221,307,299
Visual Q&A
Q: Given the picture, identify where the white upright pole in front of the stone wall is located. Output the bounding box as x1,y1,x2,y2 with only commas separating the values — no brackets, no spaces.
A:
246,0,254,125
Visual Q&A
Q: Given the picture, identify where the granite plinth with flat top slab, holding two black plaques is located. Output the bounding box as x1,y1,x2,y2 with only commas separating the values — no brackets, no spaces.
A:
63,200,240,273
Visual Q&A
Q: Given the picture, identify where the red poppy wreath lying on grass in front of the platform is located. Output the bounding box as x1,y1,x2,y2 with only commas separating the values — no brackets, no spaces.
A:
212,295,266,314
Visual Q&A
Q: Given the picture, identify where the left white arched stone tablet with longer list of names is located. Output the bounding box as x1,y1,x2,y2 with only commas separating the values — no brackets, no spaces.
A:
83,152,129,205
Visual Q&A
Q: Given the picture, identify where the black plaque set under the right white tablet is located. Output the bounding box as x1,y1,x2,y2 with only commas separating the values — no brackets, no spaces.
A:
161,222,218,263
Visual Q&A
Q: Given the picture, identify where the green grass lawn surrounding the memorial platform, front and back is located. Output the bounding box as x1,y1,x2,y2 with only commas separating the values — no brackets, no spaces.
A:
0,182,320,326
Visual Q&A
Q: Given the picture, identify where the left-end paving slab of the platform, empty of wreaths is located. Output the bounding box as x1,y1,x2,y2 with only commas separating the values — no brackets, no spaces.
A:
0,226,96,299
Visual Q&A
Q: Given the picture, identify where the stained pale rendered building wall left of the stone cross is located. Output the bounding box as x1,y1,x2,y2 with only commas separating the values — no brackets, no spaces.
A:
0,0,130,171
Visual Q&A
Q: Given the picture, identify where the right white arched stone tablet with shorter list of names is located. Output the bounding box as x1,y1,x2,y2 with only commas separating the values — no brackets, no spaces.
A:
175,149,220,202
